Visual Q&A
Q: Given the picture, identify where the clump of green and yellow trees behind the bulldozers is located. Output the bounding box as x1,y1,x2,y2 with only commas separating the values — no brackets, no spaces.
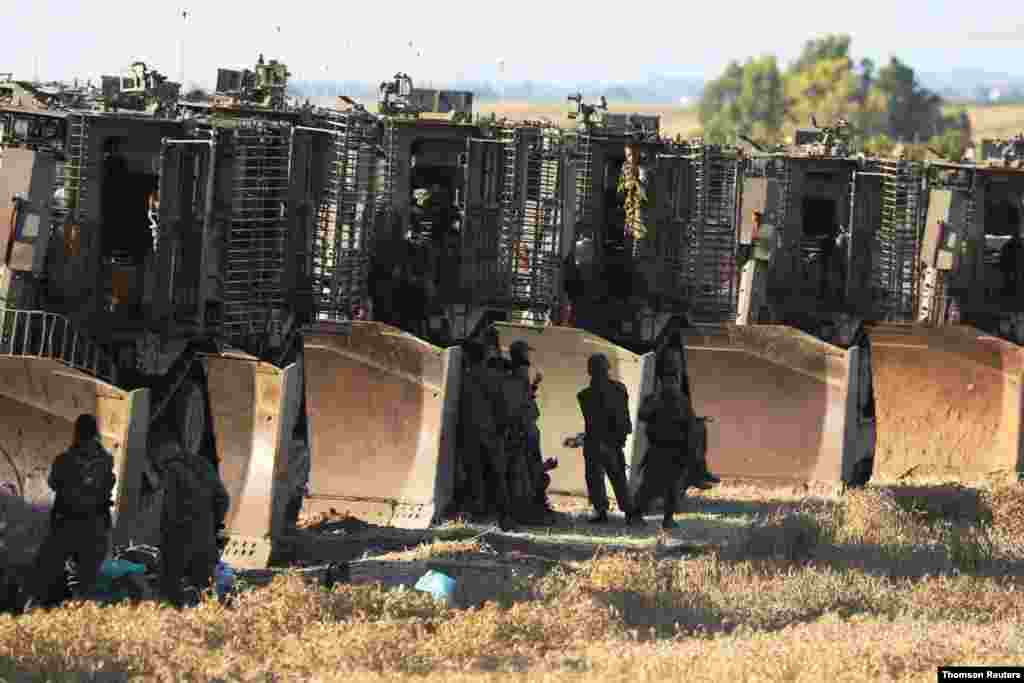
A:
698,34,971,161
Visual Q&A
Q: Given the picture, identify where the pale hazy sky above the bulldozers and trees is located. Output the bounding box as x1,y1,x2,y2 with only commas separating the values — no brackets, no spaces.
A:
0,0,1024,84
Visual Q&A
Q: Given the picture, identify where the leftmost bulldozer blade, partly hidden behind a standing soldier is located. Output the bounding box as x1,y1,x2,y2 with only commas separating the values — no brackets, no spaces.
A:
0,355,150,563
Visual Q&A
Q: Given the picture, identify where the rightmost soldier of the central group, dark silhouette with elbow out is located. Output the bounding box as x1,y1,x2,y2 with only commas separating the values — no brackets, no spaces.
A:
635,372,699,529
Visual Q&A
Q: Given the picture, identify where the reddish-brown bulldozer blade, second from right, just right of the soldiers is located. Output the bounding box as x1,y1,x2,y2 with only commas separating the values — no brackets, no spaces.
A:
671,325,874,483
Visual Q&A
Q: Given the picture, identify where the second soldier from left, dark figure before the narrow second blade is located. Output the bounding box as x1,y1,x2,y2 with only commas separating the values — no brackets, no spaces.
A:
157,439,229,608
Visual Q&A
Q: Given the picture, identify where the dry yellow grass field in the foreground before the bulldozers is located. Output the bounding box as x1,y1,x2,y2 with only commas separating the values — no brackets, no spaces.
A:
0,484,1024,683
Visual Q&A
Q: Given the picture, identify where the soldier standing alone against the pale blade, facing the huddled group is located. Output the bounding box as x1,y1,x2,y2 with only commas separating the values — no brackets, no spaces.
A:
577,353,643,524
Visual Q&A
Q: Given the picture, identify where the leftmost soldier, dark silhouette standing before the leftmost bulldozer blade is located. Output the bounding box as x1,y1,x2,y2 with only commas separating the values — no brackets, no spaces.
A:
31,414,117,606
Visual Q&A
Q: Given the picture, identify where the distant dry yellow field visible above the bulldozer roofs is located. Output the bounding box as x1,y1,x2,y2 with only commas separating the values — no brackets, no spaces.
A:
476,101,1024,140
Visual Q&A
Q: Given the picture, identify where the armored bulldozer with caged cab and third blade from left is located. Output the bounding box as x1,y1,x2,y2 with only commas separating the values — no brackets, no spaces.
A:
303,79,573,526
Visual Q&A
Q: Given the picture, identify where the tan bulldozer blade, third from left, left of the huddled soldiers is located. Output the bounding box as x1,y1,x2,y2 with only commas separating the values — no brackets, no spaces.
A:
303,322,461,528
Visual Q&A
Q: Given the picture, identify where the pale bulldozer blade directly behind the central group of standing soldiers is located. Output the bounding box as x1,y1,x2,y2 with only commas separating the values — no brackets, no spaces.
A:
495,323,654,496
